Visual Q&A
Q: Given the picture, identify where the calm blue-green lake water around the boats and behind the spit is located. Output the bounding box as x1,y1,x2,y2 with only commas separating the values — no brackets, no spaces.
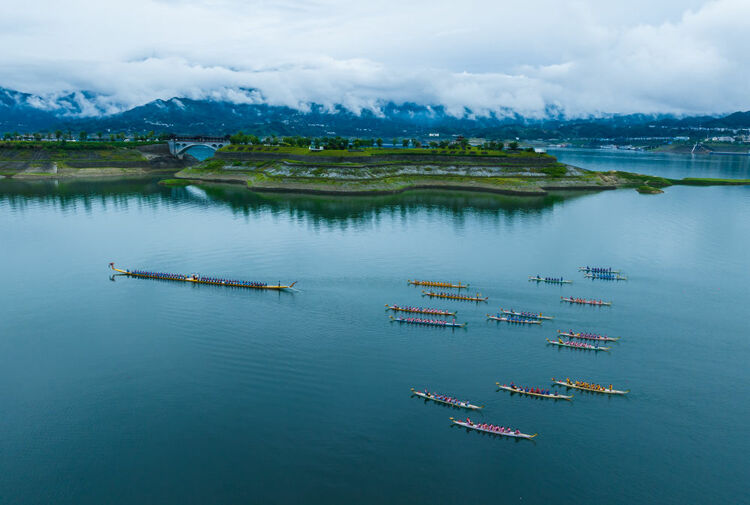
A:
0,153,750,505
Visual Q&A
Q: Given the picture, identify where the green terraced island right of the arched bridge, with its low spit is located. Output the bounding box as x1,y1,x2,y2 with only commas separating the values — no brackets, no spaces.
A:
170,145,750,196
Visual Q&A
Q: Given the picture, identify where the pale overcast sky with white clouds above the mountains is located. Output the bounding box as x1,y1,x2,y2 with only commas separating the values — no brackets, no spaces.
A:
0,0,750,116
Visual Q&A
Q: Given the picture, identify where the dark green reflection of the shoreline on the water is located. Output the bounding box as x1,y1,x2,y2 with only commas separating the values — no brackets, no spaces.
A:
0,178,589,227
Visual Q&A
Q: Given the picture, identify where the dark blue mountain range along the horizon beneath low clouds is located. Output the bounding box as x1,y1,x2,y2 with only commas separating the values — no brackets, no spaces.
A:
0,88,750,139
